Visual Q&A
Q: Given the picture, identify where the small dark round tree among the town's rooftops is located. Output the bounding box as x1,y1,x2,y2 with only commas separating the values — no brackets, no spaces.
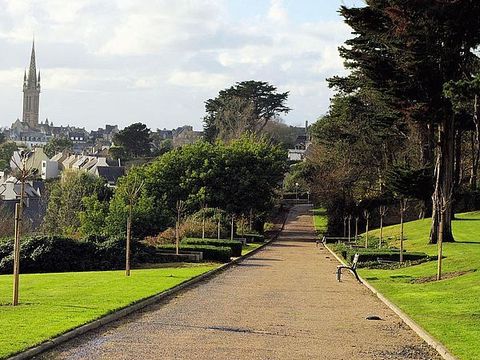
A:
113,123,151,158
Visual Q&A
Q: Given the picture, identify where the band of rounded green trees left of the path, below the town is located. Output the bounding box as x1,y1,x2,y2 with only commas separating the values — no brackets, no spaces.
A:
43,134,286,238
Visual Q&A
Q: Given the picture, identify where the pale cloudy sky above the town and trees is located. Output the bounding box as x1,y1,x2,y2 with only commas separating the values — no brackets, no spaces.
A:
0,0,360,130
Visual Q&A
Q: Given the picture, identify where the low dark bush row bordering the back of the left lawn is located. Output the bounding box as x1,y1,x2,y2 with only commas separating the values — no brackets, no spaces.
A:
0,236,154,274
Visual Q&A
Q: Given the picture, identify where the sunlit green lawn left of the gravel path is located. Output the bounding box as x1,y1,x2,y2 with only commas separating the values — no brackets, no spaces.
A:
0,264,218,358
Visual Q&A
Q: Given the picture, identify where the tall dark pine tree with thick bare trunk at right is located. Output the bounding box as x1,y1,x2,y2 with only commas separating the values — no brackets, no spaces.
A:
331,0,480,243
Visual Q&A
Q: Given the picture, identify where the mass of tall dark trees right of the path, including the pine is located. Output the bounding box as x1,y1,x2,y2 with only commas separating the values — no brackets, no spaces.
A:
299,0,480,243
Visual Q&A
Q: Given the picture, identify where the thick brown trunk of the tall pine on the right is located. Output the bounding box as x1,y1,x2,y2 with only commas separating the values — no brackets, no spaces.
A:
429,116,455,244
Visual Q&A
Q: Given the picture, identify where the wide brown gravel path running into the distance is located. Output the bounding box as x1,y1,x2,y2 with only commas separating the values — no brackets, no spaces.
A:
42,205,440,360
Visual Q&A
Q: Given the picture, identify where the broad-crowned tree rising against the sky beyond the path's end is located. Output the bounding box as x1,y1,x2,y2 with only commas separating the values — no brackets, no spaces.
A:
204,81,290,142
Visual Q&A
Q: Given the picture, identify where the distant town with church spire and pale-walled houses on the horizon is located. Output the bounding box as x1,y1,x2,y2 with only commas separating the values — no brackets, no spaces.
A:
0,42,310,233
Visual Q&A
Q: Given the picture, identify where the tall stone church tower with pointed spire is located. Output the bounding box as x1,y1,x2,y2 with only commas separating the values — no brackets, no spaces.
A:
23,42,40,129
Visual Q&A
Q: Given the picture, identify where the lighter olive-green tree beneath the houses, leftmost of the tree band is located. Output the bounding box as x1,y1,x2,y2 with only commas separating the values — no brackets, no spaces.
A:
42,171,111,236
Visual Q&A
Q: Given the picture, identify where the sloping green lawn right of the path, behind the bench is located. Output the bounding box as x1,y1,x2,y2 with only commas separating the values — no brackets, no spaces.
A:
360,212,480,360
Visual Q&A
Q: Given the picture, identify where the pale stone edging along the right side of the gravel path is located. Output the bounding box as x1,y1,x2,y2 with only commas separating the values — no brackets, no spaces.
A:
325,244,458,360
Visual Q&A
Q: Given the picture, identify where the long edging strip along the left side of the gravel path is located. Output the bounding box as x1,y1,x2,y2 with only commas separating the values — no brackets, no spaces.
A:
7,219,288,360
